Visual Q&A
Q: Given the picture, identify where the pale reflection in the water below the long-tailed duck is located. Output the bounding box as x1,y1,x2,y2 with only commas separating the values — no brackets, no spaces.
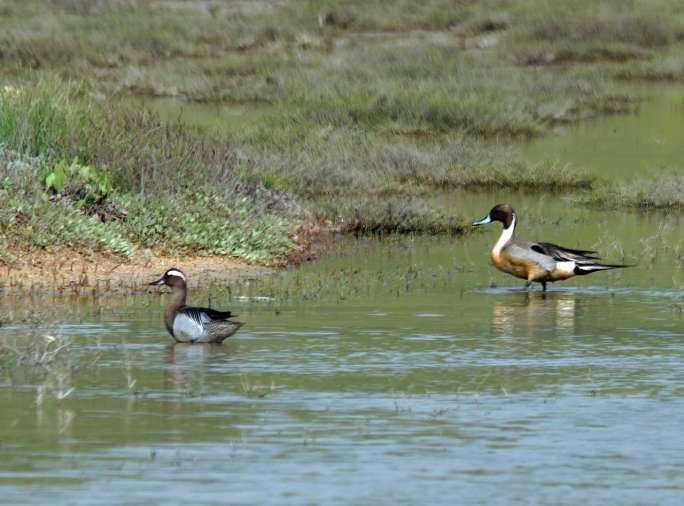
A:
491,292,581,336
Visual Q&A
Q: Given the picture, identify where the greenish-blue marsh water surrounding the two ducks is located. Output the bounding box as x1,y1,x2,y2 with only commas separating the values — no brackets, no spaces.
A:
0,91,684,505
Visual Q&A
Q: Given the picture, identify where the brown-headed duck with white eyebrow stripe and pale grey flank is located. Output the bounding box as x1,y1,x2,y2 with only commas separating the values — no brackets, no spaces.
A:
150,267,243,344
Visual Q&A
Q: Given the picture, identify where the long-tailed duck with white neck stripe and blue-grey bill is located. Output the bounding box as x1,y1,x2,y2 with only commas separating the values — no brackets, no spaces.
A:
473,204,629,290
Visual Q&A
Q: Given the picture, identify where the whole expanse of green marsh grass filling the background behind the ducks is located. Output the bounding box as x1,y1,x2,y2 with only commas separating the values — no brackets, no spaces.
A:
0,0,684,262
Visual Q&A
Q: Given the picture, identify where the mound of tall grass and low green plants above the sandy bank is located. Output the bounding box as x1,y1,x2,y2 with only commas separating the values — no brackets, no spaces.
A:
0,82,294,263
